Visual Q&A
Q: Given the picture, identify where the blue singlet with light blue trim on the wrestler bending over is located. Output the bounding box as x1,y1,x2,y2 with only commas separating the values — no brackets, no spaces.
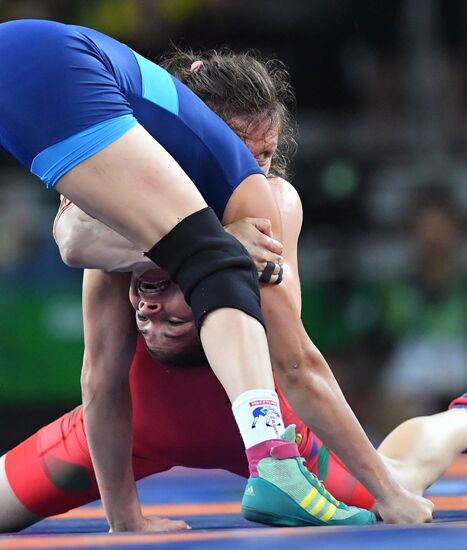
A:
0,20,262,218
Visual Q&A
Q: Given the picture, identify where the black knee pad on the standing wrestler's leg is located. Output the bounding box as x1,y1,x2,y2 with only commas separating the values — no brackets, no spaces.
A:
146,208,264,330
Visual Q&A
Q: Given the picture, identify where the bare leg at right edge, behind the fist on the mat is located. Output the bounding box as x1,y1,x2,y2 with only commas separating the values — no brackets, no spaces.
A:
378,408,467,495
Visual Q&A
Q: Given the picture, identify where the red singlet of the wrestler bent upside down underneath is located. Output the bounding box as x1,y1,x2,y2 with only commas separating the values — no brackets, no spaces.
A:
5,335,374,517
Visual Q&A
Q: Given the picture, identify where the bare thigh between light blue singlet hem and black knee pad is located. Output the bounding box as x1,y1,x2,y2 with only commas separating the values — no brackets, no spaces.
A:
56,125,206,250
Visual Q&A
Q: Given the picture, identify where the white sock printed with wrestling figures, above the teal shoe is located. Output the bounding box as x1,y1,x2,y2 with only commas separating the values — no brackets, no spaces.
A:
232,390,284,449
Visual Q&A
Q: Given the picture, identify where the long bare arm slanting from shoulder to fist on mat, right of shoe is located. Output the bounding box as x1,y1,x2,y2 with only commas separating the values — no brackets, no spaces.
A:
224,175,429,522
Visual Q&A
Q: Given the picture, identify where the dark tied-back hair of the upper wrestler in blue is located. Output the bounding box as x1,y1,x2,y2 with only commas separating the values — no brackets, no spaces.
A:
158,48,297,177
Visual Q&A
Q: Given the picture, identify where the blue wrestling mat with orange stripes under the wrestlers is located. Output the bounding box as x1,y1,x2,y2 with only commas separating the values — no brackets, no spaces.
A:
0,458,467,550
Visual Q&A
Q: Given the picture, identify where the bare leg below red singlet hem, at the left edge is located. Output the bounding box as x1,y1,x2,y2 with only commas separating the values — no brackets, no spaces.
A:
0,455,43,533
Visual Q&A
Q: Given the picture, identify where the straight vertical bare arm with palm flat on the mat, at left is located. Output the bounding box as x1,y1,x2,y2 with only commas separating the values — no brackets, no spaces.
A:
81,270,187,531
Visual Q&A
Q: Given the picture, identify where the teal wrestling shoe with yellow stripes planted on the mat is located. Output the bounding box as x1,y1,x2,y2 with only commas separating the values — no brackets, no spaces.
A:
242,430,376,527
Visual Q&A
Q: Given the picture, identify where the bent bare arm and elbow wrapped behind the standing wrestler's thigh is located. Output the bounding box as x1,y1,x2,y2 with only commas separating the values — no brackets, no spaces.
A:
54,197,153,271
